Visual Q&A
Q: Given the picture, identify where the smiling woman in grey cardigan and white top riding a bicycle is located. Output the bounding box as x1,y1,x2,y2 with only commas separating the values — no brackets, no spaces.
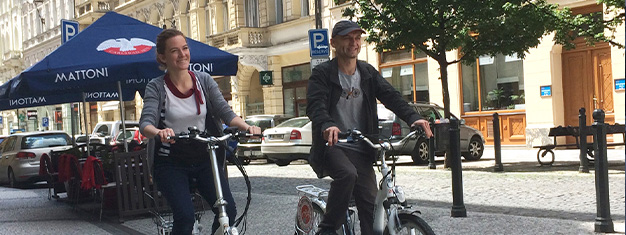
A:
139,29,261,234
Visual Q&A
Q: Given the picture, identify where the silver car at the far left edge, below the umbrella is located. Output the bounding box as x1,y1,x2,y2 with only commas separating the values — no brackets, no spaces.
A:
0,131,72,187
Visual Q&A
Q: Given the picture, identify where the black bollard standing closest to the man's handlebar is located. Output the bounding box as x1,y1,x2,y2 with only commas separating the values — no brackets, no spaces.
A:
448,117,467,217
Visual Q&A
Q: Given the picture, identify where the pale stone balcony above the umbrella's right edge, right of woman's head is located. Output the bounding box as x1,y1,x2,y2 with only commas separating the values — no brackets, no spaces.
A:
206,28,270,50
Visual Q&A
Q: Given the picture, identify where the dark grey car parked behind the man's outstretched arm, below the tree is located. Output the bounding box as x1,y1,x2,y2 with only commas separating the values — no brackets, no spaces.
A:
378,103,485,164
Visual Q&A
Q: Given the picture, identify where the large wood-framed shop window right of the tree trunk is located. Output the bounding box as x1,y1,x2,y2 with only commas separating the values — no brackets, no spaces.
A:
461,54,525,112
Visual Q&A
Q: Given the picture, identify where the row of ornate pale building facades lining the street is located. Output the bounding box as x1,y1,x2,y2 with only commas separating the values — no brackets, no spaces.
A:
0,0,625,146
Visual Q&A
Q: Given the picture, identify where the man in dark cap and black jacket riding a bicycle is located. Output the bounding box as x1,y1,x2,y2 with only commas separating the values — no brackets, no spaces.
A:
307,20,432,234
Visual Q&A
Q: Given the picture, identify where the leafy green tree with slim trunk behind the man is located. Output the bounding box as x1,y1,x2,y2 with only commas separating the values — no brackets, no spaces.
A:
344,0,624,118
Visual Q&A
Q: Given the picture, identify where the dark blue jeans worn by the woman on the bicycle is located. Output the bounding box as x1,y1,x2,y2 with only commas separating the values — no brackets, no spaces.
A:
154,159,237,235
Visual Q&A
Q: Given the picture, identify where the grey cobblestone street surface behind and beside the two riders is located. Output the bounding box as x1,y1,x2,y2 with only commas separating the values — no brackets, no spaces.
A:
123,148,626,234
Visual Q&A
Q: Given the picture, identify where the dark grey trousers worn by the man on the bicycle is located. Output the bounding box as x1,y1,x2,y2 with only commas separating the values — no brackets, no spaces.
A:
319,146,377,235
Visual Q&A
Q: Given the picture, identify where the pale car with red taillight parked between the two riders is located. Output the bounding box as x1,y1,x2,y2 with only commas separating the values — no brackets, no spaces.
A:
261,117,313,166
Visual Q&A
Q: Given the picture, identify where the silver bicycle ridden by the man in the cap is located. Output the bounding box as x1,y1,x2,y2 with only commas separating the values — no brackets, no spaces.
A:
295,129,435,235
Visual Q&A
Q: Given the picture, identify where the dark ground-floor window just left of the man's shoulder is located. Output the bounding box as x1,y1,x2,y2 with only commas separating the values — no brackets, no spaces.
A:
282,63,311,117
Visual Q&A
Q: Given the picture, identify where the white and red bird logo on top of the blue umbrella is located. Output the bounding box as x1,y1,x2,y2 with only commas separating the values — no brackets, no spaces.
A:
96,38,156,55
